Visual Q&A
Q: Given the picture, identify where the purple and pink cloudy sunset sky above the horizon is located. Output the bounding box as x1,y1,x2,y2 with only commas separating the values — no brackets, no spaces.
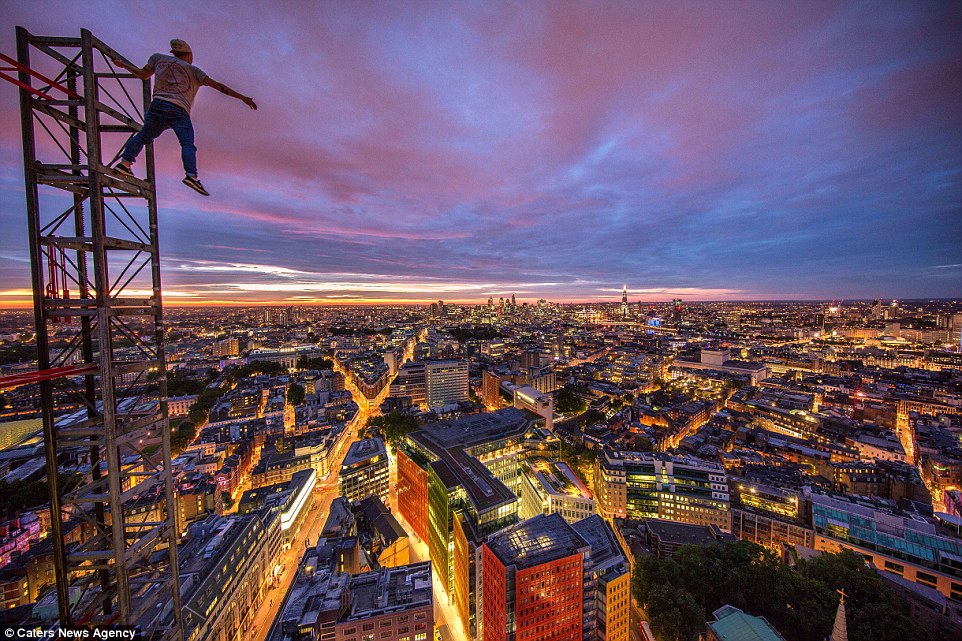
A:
0,0,962,307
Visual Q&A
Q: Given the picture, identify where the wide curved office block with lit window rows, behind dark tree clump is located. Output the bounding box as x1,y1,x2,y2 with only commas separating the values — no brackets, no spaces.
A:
595,450,729,531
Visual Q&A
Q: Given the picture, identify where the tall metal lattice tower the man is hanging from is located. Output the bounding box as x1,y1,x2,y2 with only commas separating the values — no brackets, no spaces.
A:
7,27,183,639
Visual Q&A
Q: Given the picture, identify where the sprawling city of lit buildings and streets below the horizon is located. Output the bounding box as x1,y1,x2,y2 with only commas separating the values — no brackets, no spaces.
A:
0,296,962,641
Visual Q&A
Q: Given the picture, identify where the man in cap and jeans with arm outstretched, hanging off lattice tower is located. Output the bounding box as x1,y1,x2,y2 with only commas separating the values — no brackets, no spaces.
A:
113,39,257,196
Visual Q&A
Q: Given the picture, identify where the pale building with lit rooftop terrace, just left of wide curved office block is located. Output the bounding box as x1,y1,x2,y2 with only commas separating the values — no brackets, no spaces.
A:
519,458,595,523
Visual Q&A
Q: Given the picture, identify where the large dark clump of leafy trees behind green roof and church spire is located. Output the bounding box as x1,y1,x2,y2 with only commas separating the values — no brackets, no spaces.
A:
632,541,930,641
